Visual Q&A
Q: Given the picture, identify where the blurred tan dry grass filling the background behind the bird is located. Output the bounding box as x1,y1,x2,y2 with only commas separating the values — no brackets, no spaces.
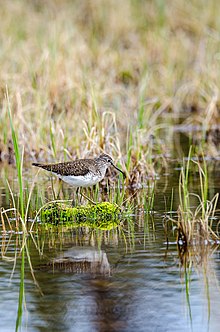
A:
0,0,220,166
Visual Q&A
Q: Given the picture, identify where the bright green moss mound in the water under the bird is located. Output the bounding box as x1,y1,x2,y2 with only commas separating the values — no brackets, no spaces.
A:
41,202,120,229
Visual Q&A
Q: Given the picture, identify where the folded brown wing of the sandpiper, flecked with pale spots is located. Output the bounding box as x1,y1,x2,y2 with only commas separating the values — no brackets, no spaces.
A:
33,160,89,176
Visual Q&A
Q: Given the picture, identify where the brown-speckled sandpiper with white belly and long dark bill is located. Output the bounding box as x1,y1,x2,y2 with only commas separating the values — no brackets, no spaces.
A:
32,154,126,201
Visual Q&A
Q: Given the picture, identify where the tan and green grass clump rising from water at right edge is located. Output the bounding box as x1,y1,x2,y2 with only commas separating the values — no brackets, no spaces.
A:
172,149,219,246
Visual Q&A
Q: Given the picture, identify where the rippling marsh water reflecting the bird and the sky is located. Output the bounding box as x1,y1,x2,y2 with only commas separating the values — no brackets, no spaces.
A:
0,156,220,332
